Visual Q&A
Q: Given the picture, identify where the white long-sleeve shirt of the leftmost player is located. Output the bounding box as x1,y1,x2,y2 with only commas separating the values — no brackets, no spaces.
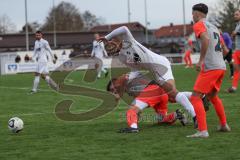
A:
32,38,54,63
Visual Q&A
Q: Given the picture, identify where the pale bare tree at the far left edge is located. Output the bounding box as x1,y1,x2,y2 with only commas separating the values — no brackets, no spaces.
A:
0,15,16,34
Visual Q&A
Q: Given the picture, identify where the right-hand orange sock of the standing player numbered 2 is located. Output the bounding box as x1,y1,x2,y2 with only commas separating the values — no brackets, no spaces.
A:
210,96,227,125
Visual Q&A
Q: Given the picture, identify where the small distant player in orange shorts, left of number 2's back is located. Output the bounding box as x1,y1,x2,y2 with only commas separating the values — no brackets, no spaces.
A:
184,37,193,68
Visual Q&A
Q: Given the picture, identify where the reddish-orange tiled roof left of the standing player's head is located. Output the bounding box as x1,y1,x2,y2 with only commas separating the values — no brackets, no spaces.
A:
154,24,193,38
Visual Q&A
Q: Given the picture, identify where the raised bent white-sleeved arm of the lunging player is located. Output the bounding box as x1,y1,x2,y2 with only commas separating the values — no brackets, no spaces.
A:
105,26,134,41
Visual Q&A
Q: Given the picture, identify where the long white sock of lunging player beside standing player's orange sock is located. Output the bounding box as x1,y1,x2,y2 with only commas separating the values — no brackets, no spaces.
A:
175,92,196,117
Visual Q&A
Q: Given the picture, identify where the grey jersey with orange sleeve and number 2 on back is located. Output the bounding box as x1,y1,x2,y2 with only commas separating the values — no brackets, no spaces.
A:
193,19,226,71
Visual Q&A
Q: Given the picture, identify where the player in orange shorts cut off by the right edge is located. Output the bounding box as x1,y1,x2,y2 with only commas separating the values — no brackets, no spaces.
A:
227,10,240,93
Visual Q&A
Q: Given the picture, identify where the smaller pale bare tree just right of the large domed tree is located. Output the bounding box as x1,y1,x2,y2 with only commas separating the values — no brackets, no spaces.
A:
82,11,104,30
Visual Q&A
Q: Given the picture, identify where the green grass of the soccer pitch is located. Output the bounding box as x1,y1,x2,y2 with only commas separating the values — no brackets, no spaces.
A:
0,66,240,160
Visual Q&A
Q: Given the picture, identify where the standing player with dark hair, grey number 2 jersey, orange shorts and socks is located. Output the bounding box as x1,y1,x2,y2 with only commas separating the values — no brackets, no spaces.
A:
187,3,230,138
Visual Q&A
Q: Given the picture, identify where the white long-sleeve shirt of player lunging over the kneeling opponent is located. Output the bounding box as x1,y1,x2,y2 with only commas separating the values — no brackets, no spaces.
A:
105,26,170,74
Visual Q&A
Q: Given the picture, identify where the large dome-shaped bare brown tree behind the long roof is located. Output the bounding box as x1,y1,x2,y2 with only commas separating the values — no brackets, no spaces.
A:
41,2,83,31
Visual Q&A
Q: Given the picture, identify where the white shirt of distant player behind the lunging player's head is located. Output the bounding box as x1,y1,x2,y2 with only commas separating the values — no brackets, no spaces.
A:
91,40,108,59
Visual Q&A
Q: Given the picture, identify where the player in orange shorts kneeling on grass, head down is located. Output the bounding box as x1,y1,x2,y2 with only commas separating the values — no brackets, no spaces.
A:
107,71,187,133
